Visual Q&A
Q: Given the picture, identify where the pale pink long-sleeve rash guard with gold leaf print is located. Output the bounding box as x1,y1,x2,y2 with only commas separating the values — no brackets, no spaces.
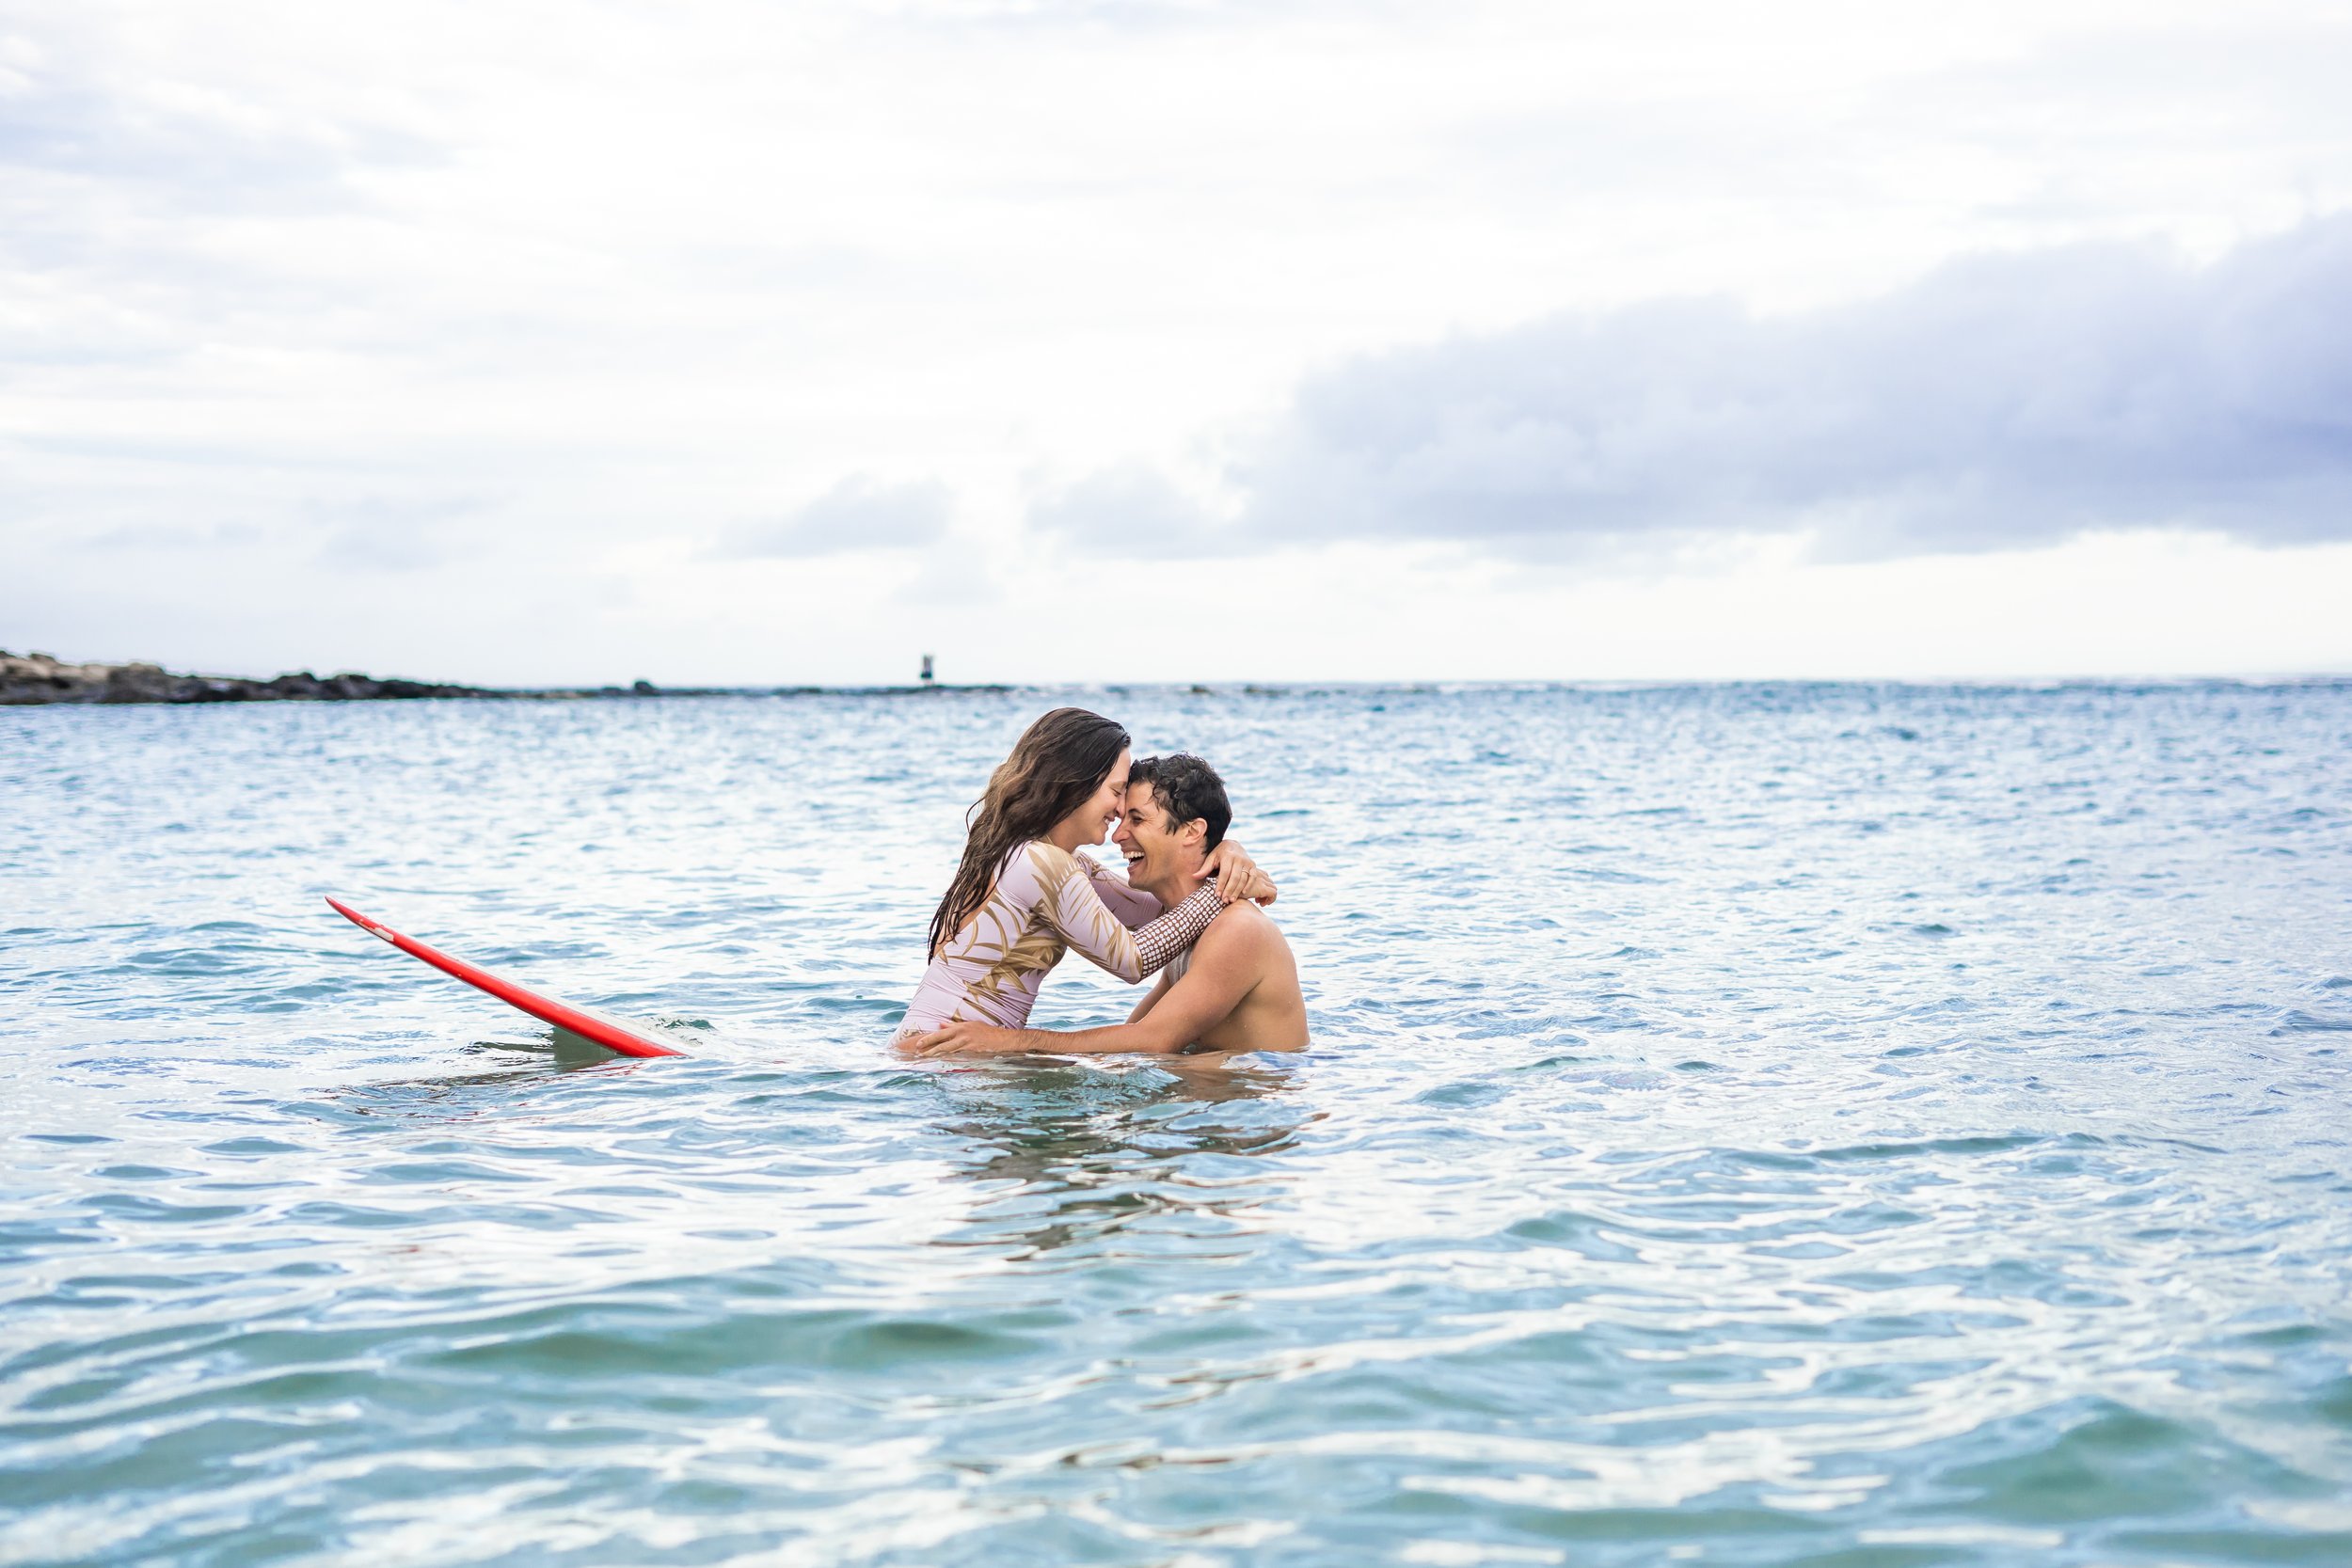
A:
898,842,1223,1037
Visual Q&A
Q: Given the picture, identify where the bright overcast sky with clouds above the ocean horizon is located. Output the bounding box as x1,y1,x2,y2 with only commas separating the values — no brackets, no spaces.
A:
0,0,2352,684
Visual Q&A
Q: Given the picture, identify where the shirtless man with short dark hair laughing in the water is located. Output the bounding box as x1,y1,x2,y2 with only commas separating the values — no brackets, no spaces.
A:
915,752,1308,1055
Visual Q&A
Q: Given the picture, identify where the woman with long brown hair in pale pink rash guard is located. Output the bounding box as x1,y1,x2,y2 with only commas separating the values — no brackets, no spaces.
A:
898,707,1275,1039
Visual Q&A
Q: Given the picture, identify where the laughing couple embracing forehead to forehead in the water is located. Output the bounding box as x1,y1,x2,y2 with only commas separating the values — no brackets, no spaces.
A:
897,707,1308,1055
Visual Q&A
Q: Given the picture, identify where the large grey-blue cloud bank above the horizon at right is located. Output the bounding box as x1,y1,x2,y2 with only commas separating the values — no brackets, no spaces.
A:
1035,216,2352,560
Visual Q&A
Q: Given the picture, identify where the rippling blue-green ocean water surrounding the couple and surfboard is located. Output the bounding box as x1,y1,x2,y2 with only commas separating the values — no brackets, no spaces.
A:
0,684,2352,1568
